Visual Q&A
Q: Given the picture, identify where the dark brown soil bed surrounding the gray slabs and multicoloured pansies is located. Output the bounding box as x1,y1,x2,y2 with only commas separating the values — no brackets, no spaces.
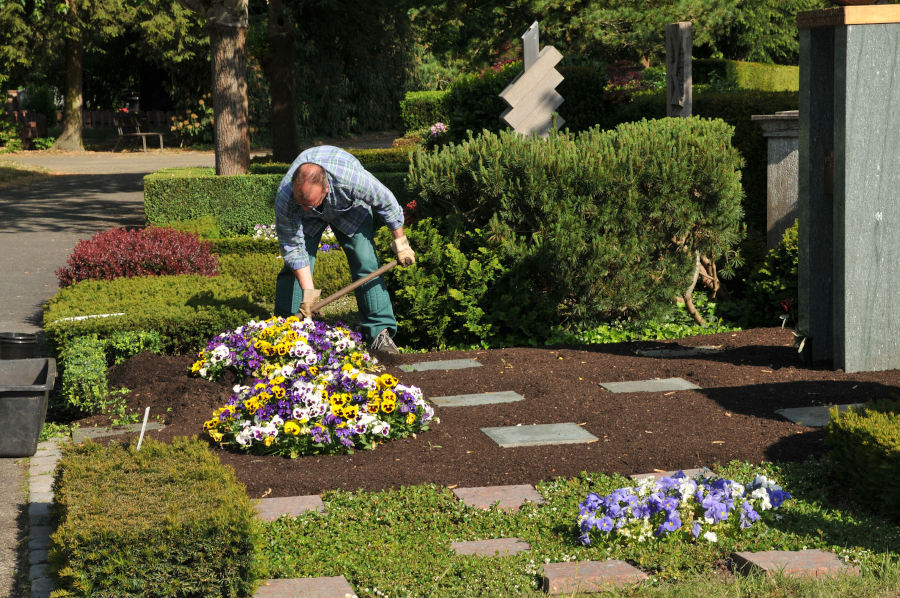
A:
84,328,900,497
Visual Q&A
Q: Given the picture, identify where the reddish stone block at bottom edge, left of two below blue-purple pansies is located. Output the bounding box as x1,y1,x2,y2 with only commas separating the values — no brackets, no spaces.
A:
544,560,647,595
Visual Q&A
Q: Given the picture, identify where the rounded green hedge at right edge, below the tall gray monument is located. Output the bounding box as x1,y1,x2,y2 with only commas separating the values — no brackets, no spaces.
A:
826,399,900,520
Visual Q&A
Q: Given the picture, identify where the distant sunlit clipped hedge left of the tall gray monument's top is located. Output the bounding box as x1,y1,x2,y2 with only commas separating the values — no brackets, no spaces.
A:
691,58,800,92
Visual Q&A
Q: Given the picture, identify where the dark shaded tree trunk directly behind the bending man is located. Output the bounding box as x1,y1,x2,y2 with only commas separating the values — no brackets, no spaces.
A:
266,0,298,163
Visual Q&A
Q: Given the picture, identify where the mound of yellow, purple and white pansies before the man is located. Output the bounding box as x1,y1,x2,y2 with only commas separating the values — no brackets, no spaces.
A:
191,317,436,458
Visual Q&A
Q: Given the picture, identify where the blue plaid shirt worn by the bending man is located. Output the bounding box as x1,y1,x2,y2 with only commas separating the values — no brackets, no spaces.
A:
275,145,403,270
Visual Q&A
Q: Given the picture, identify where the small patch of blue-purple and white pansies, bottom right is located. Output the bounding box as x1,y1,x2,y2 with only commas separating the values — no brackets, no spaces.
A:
578,471,791,545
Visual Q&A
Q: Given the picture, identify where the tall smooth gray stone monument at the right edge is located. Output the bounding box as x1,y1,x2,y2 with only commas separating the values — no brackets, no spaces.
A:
798,5,900,372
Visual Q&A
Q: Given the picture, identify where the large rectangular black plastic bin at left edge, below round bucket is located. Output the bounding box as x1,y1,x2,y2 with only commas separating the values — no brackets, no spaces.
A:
0,357,56,457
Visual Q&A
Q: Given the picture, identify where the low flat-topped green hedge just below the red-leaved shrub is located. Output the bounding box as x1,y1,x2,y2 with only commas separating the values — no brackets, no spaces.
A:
44,275,271,354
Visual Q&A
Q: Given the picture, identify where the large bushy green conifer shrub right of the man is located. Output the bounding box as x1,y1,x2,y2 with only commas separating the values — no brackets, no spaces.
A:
410,118,742,327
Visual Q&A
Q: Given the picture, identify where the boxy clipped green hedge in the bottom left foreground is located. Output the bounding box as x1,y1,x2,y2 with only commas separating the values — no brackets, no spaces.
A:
48,438,260,598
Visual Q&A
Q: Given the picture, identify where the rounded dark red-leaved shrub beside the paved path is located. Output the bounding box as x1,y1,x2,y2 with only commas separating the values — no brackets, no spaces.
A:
56,228,219,287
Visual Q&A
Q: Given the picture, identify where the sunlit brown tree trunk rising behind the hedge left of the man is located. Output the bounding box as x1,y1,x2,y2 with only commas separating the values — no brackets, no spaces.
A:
209,21,250,174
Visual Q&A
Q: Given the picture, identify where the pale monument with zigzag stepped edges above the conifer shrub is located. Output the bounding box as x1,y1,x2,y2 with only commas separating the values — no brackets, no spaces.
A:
500,21,565,137
